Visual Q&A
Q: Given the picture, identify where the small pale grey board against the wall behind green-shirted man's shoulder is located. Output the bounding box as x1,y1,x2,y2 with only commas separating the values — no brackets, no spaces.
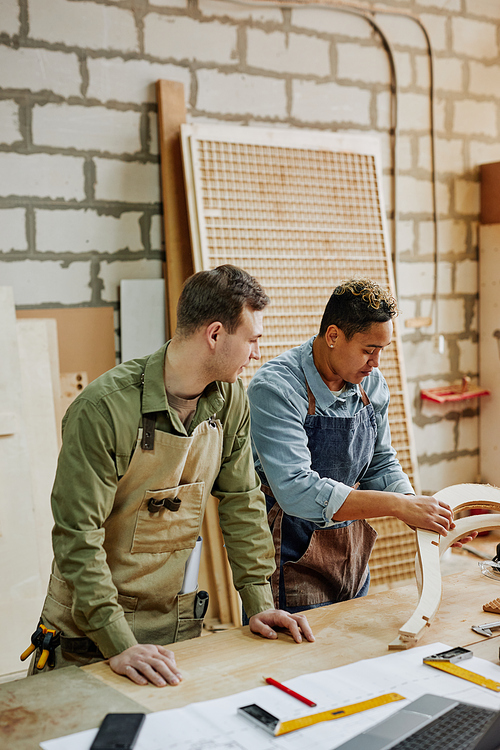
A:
120,279,166,362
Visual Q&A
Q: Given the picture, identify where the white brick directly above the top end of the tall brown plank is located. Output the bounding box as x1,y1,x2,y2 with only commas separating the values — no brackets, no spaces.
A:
144,13,237,63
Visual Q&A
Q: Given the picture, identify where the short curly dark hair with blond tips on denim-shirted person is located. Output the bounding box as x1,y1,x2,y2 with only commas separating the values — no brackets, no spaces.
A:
319,279,398,340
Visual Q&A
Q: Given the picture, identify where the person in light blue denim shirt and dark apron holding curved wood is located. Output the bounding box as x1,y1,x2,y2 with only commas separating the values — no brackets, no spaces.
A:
248,279,472,612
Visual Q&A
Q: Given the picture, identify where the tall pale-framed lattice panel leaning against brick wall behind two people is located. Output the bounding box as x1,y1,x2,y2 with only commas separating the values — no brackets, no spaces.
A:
182,125,416,582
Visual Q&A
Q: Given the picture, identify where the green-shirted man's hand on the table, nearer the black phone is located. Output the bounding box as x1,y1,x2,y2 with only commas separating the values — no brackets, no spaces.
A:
107,643,182,687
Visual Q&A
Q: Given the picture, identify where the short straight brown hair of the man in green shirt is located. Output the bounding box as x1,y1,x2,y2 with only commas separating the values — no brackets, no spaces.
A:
177,264,270,336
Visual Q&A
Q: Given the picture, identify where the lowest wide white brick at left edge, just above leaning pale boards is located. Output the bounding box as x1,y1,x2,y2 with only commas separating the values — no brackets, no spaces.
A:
2,259,91,305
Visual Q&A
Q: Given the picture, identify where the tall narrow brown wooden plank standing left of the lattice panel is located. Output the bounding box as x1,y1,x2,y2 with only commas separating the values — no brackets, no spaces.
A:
156,80,193,336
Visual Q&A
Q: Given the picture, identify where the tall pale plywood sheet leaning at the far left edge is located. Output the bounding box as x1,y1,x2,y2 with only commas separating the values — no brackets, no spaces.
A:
0,287,45,674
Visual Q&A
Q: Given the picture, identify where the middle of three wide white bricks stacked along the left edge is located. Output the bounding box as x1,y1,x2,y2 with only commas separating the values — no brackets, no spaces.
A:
0,153,85,200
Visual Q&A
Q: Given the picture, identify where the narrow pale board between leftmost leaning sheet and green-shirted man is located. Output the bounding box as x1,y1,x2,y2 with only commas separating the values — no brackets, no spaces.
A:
17,319,59,590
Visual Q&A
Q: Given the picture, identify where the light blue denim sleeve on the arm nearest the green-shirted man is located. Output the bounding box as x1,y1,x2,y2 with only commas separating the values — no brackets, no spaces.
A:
248,378,352,526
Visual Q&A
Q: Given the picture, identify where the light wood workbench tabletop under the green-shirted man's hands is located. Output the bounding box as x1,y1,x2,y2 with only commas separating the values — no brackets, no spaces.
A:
84,570,500,711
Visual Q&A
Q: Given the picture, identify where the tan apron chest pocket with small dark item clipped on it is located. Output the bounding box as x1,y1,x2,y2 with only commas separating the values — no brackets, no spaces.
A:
130,482,205,554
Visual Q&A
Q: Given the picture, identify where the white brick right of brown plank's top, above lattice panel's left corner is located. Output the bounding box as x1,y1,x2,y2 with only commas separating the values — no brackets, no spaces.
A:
196,70,286,117
